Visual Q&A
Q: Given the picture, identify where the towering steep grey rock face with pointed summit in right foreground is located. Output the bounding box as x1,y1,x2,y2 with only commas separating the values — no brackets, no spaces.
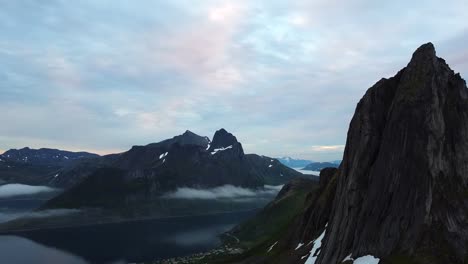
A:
317,43,468,264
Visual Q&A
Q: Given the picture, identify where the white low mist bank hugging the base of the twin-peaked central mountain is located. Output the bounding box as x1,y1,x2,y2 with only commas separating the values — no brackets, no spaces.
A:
164,185,283,200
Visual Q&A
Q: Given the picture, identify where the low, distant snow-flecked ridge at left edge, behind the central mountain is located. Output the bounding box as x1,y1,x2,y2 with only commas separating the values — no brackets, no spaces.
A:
0,147,99,187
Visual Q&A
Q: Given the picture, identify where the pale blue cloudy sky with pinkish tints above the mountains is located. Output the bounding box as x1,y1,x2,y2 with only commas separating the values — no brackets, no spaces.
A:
0,0,468,161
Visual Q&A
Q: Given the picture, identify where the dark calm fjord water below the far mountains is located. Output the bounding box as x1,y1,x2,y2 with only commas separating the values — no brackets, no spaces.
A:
0,210,256,264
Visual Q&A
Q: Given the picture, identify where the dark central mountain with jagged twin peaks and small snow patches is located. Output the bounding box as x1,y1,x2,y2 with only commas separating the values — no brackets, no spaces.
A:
45,129,303,208
